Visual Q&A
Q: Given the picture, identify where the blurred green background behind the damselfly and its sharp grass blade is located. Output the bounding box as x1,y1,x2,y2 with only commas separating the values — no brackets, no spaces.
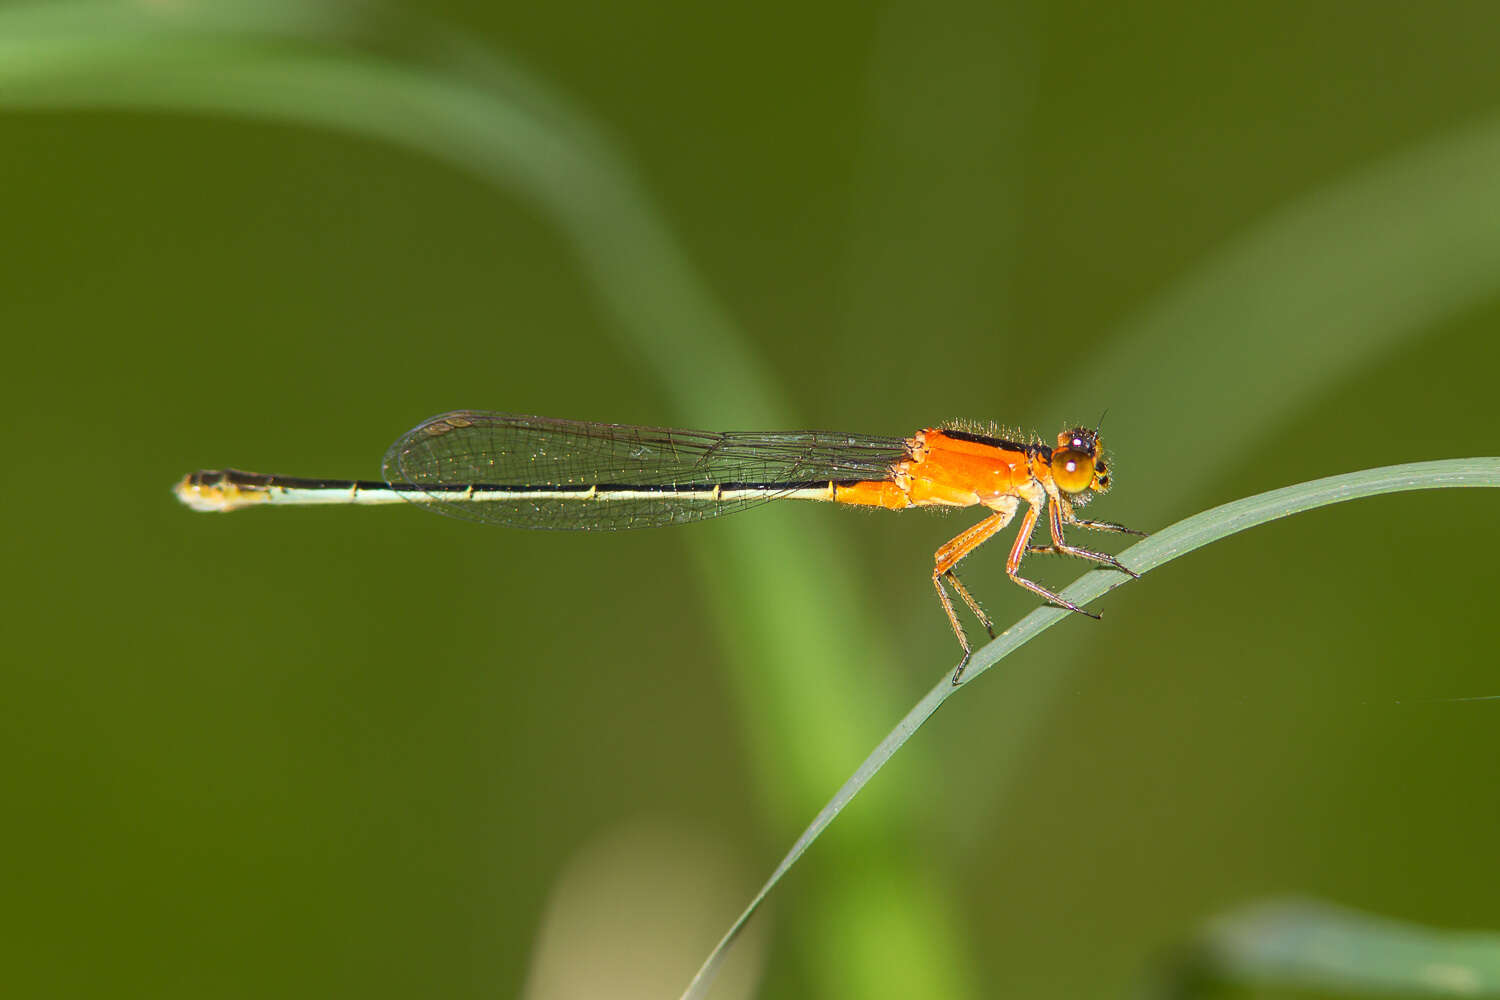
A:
0,0,1500,997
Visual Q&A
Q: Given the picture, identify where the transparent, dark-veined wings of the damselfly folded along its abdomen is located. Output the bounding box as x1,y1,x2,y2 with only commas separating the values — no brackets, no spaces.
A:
383,409,906,531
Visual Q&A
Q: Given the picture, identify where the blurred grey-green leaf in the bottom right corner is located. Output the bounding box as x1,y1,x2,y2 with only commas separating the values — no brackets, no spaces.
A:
1151,900,1500,999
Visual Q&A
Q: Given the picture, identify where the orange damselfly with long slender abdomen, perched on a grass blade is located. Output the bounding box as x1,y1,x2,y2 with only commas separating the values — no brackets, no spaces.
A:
176,409,1145,684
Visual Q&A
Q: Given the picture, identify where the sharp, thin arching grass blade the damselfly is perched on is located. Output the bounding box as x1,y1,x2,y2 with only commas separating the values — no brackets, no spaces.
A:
683,457,1500,1000
